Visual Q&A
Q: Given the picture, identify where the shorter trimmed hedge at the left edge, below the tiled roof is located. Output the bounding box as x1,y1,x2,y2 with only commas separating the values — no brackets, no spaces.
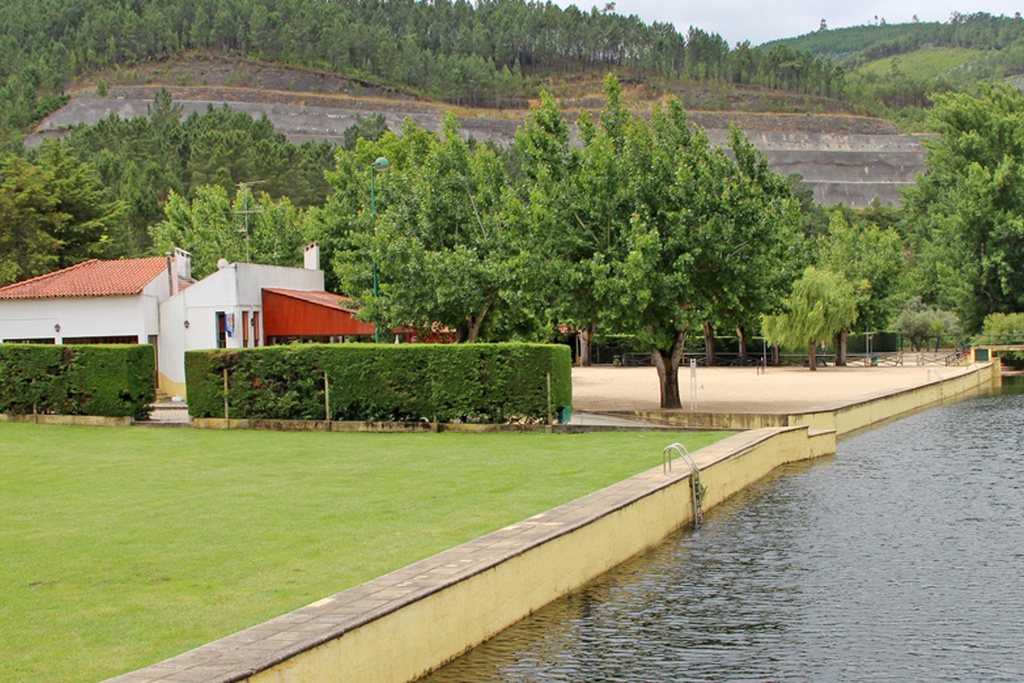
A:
0,344,157,420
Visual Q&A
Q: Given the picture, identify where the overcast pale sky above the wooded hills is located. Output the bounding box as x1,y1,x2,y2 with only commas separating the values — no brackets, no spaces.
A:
554,0,1024,46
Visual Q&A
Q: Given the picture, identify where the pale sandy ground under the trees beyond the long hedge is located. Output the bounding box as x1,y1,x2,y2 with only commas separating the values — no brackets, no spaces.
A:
572,366,968,414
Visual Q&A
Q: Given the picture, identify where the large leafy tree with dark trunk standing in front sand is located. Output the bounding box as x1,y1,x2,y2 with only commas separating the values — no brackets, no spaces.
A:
583,76,798,409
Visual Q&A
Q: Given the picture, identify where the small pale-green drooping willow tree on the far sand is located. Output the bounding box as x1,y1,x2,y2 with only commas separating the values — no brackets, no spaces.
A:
762,266,857,371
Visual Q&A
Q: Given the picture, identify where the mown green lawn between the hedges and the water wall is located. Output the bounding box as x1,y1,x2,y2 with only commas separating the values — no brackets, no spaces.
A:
0,423,726,682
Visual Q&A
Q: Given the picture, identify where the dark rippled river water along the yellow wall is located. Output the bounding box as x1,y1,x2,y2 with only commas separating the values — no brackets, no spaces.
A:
424,378,1024,683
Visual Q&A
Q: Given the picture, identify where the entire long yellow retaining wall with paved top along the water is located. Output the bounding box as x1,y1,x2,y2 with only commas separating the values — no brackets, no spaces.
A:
103,365,998,683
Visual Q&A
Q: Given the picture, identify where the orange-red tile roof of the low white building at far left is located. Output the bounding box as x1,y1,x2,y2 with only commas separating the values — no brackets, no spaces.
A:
0,256,167,299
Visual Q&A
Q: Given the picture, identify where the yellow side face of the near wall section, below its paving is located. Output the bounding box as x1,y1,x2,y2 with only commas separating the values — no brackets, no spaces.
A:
248,427,835,683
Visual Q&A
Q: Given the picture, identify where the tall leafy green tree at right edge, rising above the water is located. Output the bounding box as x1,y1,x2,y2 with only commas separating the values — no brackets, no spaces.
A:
903,86,1024,331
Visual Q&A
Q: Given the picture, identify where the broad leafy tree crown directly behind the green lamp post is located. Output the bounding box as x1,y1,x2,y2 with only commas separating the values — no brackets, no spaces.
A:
317,116,543,342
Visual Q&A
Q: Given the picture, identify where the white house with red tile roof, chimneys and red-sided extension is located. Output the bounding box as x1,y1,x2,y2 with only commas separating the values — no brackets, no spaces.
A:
0,244,374,396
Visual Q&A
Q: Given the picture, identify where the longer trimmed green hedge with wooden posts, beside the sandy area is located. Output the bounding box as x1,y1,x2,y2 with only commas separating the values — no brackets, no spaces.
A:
185,344,572,423
